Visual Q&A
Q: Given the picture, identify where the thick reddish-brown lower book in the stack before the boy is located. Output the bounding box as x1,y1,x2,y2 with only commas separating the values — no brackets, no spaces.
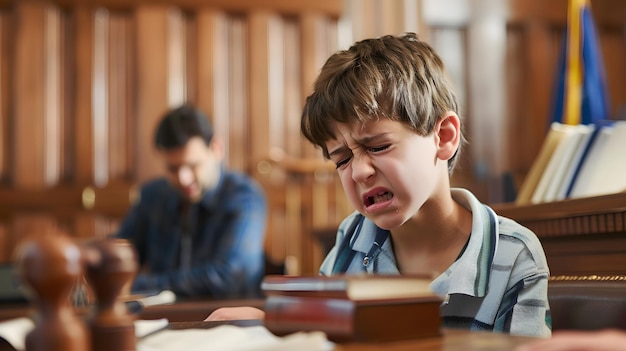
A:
264,295,441,342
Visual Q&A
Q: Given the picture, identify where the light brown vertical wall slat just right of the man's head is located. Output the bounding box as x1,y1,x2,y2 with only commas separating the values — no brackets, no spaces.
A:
223,16,245,172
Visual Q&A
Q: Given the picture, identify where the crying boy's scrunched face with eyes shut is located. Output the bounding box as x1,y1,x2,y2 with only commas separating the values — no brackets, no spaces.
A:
326,118,449,230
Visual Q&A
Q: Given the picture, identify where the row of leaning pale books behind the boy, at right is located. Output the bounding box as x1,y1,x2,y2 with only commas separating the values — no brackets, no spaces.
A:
516,121,626,205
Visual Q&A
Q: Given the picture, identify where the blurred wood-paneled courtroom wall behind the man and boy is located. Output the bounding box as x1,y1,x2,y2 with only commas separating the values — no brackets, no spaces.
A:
0,0,626,274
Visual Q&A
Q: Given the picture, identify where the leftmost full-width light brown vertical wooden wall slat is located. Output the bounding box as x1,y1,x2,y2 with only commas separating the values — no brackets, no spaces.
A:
12,2,52,188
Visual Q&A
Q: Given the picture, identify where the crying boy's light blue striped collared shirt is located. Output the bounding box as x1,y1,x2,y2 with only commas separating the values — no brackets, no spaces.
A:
320,188,551,337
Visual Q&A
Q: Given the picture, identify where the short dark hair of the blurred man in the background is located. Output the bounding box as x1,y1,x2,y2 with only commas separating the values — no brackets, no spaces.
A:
154,104,213,149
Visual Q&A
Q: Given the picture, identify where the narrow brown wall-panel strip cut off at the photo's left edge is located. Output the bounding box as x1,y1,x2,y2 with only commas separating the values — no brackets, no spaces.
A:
0,10,13,183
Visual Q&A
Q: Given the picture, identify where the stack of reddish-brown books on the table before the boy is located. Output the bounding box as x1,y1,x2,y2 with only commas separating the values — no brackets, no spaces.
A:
262,275,442,342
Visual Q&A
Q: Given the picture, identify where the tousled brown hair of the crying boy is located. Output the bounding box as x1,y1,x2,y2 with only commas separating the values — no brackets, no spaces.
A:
300,33,464,173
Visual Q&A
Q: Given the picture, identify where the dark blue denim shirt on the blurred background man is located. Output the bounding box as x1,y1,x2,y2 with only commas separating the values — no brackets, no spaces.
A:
116,170,267,298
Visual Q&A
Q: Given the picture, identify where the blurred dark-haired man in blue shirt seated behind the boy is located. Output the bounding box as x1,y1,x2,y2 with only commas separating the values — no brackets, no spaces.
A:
117,104,267,299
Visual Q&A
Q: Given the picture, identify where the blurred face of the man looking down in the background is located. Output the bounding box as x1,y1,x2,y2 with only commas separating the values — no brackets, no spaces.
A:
159,137,222,202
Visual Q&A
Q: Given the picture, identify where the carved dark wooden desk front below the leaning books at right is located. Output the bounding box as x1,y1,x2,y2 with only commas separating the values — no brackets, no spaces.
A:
492,192,626,277
